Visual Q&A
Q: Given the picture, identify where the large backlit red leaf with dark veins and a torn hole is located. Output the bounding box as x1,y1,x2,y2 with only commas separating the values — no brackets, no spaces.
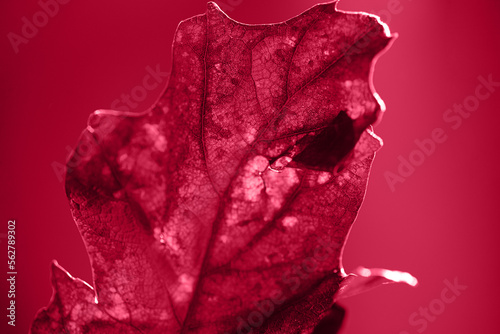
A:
32,2,402,334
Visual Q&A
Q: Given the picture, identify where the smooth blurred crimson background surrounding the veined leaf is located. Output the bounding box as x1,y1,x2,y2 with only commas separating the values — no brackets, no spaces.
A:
0,0,500,334
